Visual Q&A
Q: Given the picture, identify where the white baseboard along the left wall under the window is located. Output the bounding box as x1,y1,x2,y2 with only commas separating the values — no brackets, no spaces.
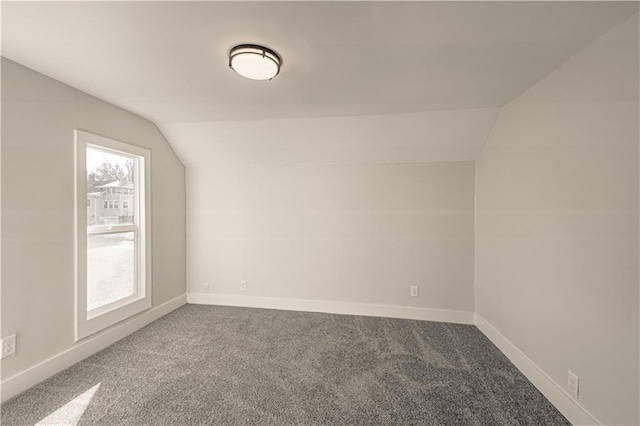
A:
0,294,187,402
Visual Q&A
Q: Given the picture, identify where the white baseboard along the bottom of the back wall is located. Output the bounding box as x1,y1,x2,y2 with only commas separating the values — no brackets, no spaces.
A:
187,293,474,324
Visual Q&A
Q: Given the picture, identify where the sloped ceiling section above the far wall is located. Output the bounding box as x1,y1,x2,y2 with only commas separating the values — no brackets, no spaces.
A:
161,108,499,167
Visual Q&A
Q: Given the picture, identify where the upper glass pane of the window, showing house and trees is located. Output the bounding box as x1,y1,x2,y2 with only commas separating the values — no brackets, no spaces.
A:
87,147,138,228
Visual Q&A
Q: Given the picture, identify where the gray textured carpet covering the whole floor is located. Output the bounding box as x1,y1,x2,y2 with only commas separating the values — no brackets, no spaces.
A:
1,305,569,425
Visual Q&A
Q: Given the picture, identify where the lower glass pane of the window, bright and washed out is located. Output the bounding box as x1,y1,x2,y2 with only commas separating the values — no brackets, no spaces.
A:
87,232,136,311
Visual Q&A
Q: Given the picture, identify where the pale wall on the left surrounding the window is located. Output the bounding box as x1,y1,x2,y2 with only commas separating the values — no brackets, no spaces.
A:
2,58,186,380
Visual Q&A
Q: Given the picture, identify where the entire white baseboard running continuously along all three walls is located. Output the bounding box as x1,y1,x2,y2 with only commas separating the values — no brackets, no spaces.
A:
0,293,601,425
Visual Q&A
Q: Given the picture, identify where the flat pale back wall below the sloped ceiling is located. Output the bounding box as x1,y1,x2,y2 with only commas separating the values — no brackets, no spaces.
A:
187,162,475,312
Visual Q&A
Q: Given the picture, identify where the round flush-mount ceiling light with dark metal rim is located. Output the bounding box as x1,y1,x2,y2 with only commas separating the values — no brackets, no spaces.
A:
229,44,282,80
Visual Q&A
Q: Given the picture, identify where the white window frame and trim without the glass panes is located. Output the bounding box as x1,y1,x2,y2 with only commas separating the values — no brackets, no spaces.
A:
75,130,152,341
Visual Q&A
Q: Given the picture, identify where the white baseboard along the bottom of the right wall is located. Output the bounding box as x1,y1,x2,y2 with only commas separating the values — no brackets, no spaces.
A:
476,314,602,425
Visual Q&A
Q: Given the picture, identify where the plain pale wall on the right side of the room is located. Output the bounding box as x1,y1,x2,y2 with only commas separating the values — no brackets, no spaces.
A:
476,15,640,424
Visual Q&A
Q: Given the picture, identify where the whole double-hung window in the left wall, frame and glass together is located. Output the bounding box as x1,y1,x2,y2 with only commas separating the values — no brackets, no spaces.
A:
76,130,151,340
